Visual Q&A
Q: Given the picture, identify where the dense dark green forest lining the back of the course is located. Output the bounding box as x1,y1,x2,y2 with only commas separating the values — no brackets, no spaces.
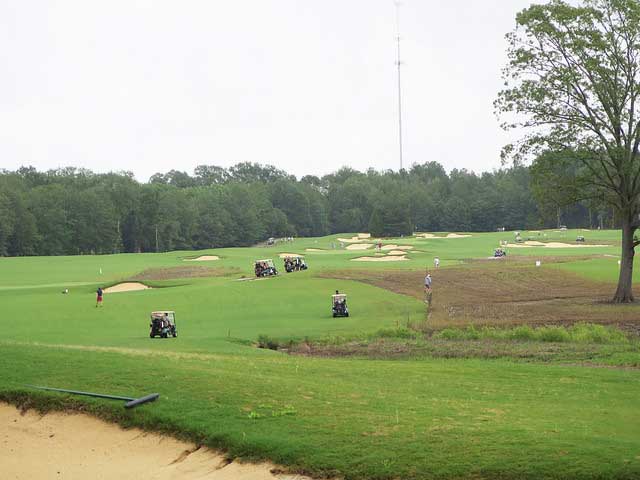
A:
0,162,614,256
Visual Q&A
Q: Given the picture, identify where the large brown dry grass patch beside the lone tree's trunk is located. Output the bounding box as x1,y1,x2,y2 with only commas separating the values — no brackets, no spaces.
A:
323,264,640,331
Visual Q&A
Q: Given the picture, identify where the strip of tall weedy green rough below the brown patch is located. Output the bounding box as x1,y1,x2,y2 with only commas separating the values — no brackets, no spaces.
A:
272,324,640,368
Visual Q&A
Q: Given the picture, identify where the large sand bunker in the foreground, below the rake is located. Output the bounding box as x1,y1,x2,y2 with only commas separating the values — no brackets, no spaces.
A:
0,403,307,480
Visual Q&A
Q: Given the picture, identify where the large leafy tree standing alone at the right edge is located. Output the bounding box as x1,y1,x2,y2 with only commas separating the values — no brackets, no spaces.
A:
496,0,640,303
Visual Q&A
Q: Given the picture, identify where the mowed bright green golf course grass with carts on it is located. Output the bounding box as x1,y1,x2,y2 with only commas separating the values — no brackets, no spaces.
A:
0,231,640,479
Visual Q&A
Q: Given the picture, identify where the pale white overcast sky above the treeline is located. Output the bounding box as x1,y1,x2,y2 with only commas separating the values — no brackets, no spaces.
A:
0,0,531,181
